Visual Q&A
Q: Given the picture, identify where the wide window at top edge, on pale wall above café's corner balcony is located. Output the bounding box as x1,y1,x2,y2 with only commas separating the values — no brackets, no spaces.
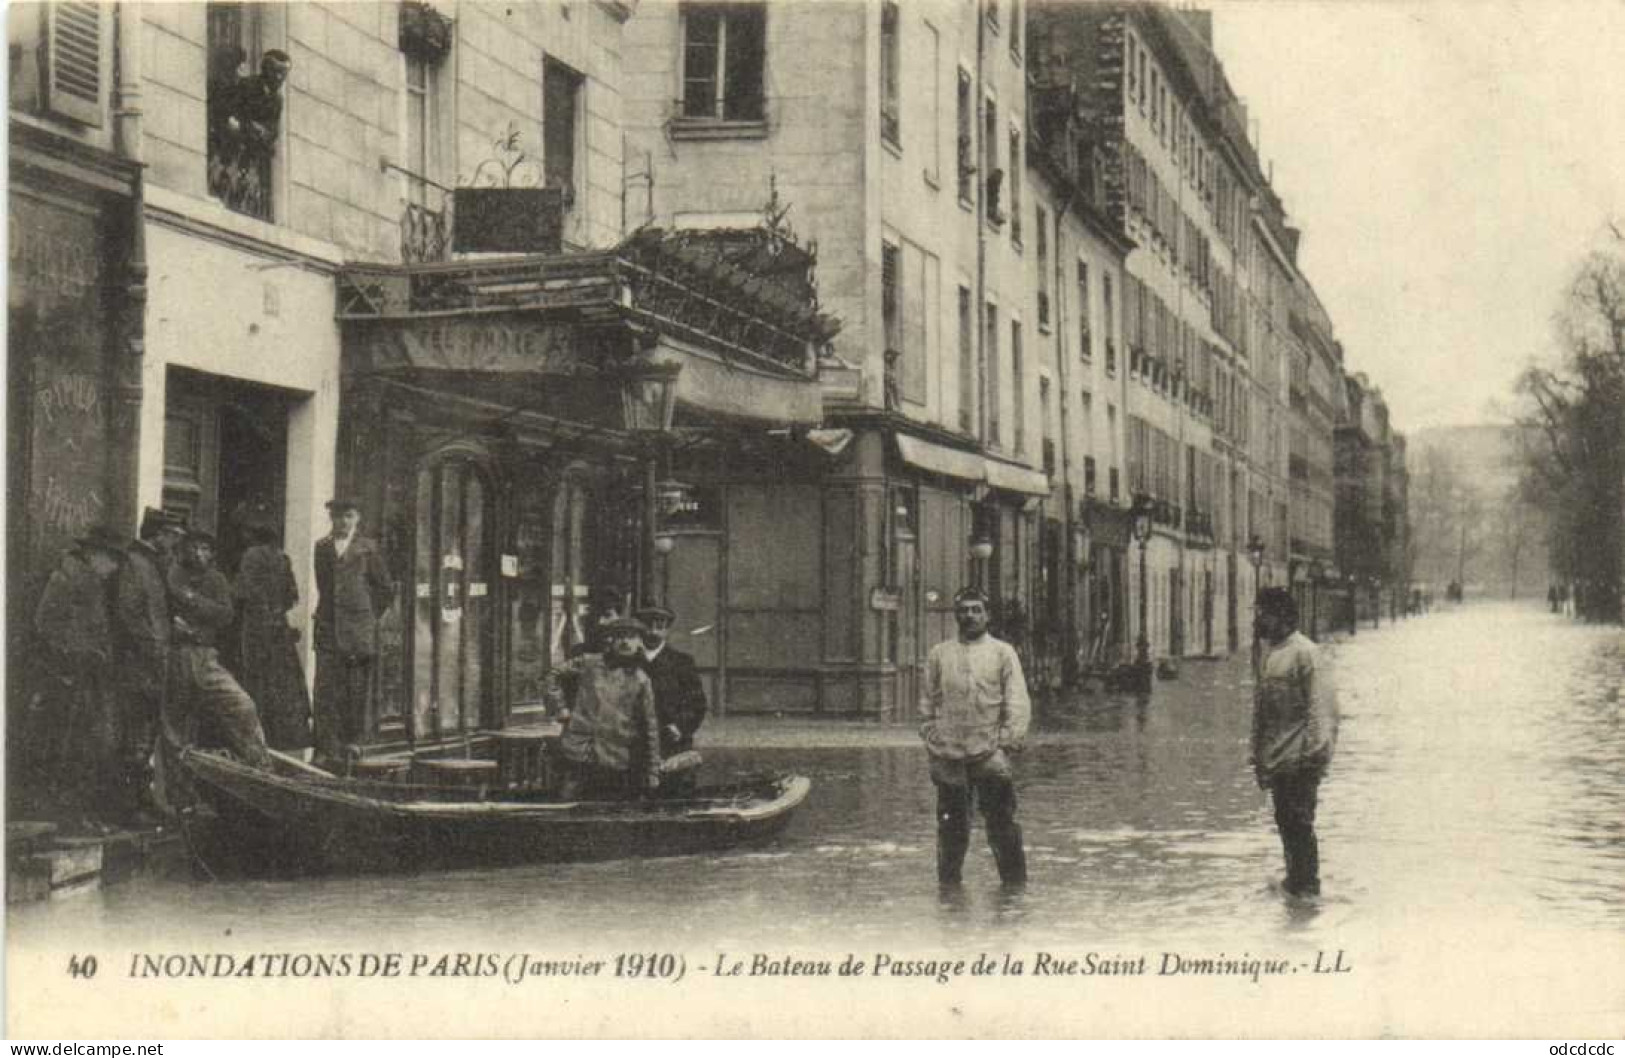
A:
683,3,767,122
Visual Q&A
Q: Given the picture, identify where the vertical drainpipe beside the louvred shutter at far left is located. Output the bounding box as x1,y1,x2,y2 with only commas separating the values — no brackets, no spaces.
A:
106,3,146,536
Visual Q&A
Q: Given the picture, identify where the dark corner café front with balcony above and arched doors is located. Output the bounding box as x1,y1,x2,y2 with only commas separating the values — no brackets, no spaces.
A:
336,232,834,749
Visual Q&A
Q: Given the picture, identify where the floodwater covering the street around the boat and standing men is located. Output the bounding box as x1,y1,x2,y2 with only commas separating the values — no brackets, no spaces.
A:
10,603,1625,1035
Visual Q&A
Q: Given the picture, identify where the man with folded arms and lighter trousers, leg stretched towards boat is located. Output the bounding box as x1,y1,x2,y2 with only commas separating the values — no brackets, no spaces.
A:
164,530,271,776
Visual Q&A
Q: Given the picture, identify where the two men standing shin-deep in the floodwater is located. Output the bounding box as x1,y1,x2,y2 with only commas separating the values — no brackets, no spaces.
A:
920,588,1337,899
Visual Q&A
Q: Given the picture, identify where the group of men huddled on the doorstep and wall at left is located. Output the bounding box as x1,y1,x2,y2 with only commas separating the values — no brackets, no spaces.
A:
24,499,392,832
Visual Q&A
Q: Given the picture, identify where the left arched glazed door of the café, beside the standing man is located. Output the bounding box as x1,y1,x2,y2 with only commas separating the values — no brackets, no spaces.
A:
413,457,496,741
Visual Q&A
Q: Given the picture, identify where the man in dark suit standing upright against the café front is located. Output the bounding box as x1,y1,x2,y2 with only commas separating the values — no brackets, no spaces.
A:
314,497,393,765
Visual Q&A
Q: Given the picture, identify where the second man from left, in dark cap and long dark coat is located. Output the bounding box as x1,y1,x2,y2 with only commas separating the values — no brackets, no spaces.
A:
114,507,185,822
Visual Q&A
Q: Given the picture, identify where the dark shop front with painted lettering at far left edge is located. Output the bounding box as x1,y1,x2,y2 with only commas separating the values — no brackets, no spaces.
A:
7,120,145,812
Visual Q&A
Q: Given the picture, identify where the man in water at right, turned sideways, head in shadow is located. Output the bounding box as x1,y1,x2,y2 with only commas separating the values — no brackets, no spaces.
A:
1251,588,1337,897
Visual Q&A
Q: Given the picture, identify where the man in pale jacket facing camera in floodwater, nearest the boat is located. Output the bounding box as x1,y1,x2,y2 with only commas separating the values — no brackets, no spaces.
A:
920,588,1032,886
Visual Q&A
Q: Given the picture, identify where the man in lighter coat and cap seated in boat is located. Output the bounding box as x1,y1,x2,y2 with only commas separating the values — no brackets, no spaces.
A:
543,618,660,800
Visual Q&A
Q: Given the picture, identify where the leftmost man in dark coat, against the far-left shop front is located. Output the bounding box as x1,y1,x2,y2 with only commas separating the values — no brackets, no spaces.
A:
31,525,125,832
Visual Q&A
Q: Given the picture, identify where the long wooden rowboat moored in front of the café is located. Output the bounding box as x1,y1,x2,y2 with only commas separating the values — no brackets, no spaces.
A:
180,749,813,874
